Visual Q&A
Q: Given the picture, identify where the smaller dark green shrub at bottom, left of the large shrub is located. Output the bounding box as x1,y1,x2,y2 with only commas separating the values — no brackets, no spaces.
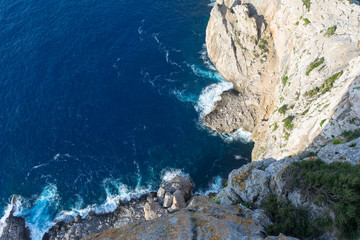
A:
261,194,331,239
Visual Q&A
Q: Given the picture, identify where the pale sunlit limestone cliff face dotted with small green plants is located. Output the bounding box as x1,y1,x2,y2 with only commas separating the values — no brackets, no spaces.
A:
205,0,360,160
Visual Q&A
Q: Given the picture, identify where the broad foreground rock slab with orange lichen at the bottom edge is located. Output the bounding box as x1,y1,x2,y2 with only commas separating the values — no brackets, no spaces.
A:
85,202,295,240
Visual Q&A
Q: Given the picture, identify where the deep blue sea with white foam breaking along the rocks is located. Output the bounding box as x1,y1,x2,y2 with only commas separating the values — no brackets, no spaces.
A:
0,0,252,238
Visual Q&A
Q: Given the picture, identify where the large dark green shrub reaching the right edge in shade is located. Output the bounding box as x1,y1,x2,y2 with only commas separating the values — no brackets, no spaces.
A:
284,159,360,239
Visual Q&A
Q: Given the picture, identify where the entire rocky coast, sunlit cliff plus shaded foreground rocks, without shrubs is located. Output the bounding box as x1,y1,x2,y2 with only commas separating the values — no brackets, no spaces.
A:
0,0,360,240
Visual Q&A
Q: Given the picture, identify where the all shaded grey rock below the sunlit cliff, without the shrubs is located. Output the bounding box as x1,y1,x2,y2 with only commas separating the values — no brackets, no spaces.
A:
0,138,360,240
